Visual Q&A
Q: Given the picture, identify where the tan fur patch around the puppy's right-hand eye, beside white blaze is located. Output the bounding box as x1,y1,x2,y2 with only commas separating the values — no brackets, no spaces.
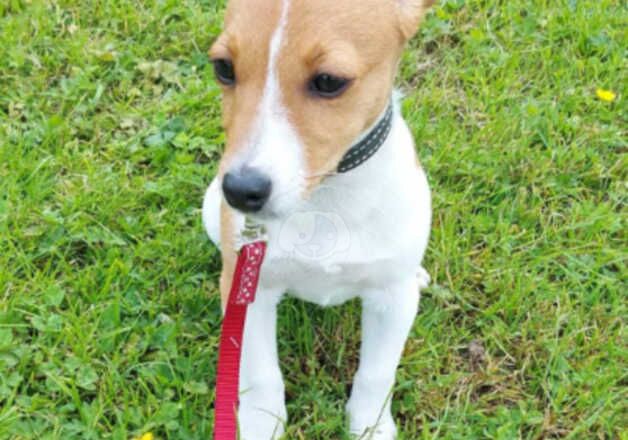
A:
278,0,403,189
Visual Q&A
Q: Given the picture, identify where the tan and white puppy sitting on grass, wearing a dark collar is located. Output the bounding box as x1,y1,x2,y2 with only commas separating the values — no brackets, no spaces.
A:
202,0,434,440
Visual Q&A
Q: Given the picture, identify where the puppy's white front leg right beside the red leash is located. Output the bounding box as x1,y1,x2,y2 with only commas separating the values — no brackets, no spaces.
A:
238,286,286,440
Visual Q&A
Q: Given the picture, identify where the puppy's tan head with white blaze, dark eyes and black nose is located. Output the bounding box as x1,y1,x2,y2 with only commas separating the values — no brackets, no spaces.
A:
210,0,433,216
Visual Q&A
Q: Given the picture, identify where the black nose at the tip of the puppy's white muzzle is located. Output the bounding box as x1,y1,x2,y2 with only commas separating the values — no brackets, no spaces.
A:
222,167,272,212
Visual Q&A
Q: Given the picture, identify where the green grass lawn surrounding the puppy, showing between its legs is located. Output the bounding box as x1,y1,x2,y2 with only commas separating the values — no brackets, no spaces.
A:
0,0,628,440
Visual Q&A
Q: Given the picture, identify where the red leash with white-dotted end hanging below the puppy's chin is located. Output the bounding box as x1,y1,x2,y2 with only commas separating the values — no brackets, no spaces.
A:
214,241,266,440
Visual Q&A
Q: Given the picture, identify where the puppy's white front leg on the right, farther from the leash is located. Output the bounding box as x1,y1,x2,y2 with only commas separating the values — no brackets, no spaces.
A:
347,277,419,440
